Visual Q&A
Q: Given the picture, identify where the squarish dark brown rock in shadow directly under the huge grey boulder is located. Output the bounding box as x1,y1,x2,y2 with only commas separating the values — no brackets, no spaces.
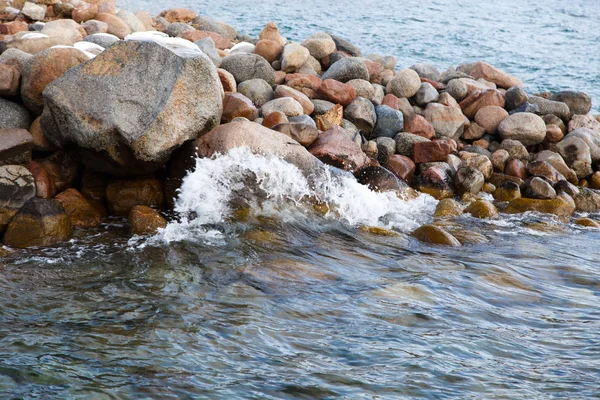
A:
106,178,164,216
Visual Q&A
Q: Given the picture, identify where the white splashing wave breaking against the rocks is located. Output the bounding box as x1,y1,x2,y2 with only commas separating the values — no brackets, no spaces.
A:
156,147,437,242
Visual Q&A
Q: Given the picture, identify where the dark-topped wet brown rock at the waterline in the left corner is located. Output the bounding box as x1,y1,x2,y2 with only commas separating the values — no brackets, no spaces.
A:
2,197,73,248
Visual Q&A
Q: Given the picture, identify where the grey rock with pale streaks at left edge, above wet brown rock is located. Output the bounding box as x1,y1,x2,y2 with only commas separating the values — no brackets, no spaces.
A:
0,165,36,233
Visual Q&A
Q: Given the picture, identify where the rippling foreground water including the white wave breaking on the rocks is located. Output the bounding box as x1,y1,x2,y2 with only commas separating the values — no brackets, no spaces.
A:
0,150,600,399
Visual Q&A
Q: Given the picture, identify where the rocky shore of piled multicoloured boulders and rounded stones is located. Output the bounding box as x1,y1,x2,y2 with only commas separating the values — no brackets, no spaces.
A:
0,0,600,248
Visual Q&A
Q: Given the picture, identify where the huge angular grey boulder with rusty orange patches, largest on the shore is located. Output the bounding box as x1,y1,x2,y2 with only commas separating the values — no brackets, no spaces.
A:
41,41,222,174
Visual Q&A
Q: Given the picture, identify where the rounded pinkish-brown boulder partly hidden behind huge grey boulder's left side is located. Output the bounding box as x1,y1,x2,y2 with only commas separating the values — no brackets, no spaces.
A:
21,48,88,115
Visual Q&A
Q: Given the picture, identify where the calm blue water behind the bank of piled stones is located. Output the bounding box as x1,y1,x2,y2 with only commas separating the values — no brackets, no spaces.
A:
119,0,600,112
